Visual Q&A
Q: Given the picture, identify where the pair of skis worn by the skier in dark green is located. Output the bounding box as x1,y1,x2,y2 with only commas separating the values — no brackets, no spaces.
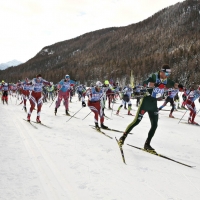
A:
115,137,195,168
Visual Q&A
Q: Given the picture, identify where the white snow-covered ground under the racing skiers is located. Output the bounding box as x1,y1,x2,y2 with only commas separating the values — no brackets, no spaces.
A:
0,96,200,200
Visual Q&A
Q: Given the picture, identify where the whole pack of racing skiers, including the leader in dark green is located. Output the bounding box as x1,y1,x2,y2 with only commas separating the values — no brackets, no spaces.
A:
0,64,200,151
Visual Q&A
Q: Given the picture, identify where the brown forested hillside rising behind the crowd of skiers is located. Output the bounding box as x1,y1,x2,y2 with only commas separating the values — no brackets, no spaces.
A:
0,0,200,85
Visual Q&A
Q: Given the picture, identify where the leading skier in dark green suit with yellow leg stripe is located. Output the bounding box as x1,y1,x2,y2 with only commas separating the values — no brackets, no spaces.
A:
119,64,184,151
